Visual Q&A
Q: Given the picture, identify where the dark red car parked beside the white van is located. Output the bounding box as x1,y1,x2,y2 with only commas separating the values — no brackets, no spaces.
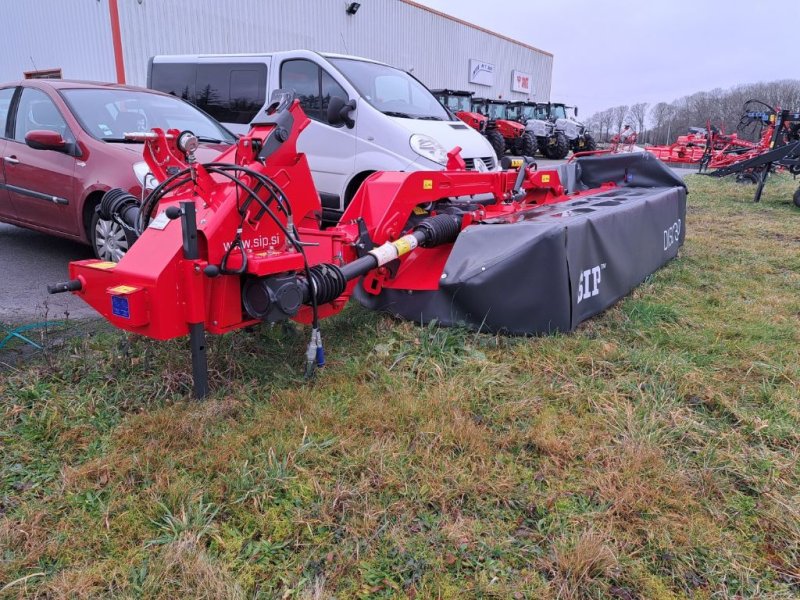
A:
0,79,235,261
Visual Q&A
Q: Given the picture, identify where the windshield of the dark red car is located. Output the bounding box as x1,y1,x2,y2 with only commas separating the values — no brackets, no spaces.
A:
61,88,236,144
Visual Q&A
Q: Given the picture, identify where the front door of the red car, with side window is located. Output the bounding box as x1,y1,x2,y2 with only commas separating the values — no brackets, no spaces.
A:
2,87,80,235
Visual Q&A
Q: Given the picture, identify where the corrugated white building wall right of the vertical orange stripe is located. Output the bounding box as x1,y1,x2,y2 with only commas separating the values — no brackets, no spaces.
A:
119,0,553,101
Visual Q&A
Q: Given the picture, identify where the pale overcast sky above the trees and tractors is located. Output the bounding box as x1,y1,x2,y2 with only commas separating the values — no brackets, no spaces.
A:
416,0,800,117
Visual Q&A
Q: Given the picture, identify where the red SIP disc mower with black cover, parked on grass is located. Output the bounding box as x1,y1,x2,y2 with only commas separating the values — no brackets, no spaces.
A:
48,93,686,397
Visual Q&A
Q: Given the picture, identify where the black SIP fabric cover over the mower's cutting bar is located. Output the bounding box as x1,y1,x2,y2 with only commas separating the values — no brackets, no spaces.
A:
356,152,686,334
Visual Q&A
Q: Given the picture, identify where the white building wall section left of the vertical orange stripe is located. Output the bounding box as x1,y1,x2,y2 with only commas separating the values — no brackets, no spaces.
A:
0,0,116,83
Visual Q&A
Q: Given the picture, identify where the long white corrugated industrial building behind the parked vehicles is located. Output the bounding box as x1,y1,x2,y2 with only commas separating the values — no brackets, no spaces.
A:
0,0,553,101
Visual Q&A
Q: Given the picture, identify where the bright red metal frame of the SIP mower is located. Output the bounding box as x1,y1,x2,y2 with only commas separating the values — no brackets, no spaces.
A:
64,101,613,339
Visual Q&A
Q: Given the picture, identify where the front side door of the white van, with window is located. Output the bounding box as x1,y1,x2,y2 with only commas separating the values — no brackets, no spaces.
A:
280,58,356,210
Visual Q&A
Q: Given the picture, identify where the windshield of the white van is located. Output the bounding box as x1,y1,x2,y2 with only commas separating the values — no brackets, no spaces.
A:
329,58,451,121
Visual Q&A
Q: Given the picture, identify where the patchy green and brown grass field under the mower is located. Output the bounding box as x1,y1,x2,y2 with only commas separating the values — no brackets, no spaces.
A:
0,176,800,600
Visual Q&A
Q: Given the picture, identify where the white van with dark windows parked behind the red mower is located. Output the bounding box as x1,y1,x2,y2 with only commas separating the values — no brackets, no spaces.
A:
147,50,498,219
